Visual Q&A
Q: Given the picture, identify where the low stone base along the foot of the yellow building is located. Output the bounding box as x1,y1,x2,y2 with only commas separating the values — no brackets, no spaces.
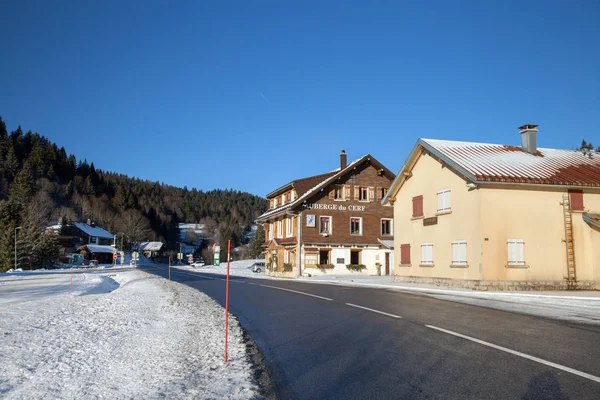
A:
394,276,596,291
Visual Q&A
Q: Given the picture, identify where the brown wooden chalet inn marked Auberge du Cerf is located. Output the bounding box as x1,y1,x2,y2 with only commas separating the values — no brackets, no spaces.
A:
257,151,395,277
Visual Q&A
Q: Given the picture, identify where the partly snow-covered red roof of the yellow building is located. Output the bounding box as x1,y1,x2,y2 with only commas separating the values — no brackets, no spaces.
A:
419,139,600,187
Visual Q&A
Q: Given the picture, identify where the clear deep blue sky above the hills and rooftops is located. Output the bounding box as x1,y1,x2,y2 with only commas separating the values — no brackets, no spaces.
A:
0,0,600,195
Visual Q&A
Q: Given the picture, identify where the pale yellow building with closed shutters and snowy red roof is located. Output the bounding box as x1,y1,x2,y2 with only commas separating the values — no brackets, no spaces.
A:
382,125,600,290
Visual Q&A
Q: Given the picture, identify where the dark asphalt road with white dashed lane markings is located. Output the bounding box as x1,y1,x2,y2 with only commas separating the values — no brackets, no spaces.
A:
139,266,600,400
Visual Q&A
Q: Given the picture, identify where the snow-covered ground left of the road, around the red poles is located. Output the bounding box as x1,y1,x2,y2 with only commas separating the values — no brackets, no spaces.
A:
0,270,260,399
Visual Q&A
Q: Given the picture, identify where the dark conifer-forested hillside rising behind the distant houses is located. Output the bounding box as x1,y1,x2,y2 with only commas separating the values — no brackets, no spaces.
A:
0,118,265,271
